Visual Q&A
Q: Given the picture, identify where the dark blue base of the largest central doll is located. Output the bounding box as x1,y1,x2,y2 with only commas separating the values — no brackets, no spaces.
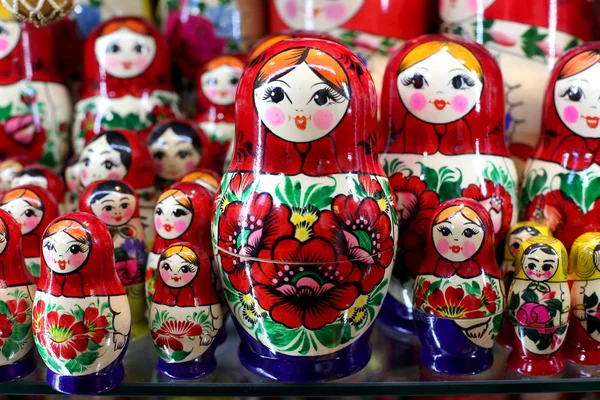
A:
235,323,371,382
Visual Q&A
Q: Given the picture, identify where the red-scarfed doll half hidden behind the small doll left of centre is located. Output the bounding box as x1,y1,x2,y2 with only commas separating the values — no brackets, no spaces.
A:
145,182,215,305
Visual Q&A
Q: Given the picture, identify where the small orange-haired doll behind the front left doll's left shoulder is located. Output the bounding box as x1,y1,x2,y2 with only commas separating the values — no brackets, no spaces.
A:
0,185,59,280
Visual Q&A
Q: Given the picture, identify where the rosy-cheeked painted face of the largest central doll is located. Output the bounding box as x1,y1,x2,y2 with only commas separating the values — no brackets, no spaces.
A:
254,62,350,143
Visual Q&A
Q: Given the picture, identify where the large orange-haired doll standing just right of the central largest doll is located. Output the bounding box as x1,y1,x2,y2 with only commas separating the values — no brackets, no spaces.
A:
378,35,518,333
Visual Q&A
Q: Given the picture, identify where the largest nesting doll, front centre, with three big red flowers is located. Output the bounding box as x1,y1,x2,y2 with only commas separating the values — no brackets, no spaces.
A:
212,39,397,381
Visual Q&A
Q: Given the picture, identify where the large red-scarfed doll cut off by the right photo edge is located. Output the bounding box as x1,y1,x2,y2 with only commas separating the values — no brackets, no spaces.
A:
520,42,600,249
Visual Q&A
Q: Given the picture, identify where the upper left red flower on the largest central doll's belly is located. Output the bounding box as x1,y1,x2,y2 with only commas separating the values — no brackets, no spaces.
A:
219,193,294,293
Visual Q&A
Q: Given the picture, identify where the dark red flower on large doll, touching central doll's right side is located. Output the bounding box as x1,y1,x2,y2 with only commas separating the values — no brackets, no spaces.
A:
390,174,440,276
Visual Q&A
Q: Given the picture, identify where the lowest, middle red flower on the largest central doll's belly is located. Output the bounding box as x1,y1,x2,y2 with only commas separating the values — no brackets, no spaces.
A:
252,237,362,330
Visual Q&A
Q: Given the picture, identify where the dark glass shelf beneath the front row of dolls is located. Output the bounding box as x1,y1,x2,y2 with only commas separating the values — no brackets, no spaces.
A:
0,321,600,397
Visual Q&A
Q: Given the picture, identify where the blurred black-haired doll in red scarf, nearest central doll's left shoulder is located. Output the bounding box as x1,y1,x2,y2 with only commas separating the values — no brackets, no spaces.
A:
147,119,212,191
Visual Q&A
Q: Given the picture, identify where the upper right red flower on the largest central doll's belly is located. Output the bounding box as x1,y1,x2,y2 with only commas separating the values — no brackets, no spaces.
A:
315,194,394,293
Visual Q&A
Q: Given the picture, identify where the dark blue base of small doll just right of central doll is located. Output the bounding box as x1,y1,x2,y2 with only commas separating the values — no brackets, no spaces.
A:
415,310,494,375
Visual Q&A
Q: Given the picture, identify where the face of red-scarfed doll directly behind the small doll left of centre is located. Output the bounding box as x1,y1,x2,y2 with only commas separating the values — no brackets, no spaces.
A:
154,196,192,240
